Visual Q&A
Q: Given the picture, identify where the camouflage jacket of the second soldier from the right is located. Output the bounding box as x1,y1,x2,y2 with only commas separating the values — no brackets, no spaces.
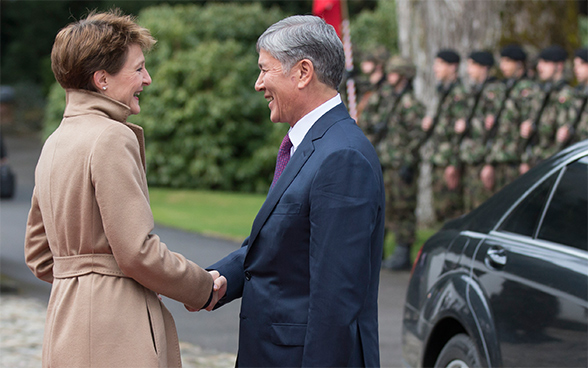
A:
522,81,576,163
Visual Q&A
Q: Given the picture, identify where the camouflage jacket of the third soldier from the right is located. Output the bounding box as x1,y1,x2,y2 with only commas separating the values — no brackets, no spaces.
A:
486,78,540,164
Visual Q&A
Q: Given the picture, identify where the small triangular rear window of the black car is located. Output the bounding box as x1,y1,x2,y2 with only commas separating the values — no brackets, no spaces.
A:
498,173,558,237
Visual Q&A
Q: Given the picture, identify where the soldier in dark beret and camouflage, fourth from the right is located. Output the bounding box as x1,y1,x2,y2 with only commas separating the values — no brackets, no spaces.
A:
455,51,505,212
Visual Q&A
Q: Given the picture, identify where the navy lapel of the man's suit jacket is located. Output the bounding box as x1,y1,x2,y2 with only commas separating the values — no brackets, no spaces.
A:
249,103,350,247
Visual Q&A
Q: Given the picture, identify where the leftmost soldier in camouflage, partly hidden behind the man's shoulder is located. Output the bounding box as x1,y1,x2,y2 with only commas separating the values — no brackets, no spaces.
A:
357,48,387,146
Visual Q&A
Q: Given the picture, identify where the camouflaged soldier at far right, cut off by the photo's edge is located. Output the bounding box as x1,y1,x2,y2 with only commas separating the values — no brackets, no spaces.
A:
557,48,588,149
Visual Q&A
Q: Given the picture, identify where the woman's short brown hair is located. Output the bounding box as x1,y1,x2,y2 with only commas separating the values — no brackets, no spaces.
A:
51,9,157,91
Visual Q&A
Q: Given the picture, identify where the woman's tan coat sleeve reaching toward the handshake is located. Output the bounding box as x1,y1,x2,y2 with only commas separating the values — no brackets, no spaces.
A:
90,124,213,308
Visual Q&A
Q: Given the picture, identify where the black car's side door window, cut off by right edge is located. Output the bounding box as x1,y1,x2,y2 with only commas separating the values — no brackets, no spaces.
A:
537,157,588,251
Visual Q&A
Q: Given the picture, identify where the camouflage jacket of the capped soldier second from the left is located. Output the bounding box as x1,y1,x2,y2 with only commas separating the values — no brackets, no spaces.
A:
376,87,426,169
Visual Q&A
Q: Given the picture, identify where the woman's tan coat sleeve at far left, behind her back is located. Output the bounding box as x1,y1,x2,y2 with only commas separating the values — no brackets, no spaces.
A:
24,188,53,283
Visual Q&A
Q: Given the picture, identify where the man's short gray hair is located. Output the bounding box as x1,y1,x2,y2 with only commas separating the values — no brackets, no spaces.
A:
257,15,345,90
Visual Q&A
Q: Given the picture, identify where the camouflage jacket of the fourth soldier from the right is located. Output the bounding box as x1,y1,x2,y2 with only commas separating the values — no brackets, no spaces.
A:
459,81,506,165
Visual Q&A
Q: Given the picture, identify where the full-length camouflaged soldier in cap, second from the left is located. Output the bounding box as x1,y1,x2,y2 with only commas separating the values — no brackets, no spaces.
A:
376,56,425,270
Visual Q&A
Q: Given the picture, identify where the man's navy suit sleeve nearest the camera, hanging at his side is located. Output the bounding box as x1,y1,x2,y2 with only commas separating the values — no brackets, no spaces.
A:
302,150,383,367
